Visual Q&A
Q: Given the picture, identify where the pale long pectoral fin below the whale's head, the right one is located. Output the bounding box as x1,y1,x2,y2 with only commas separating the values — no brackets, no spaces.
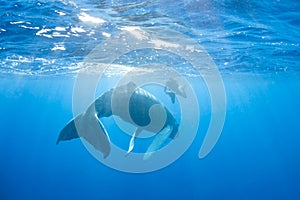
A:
143,126,172,160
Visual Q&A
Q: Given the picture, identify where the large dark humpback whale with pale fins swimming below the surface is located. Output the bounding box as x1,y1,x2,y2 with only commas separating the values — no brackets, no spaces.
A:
56,82,179,159
